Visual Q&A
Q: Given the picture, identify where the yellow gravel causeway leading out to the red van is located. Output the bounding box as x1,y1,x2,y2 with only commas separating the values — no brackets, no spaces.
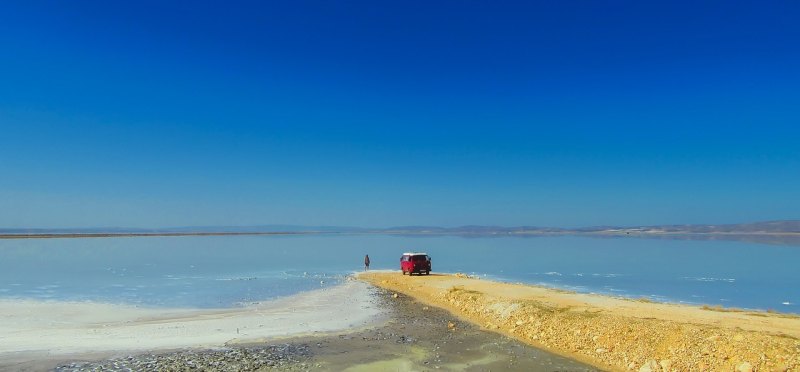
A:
359,272,800,371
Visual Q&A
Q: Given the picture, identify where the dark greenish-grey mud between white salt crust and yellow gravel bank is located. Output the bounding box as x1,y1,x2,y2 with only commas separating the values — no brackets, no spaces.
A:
238,291,597,372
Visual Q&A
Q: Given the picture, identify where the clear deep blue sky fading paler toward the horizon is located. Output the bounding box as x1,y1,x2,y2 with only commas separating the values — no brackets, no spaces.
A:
0,0,800,227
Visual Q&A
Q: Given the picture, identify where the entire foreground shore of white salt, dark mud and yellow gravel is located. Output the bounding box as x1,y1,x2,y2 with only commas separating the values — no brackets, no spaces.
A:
0,270,800,371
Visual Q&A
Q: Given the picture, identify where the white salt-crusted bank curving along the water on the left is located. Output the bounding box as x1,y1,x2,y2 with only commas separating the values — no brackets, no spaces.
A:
0,281,380,360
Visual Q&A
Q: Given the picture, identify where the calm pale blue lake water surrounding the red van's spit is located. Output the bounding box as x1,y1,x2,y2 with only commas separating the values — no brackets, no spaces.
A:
0,235,800,313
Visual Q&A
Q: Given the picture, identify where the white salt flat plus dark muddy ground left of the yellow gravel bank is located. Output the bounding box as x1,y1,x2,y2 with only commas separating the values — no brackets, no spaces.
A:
0,280,596,372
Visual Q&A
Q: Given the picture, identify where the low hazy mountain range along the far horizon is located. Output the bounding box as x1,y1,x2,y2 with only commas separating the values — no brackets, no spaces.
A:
0,220,800,246
